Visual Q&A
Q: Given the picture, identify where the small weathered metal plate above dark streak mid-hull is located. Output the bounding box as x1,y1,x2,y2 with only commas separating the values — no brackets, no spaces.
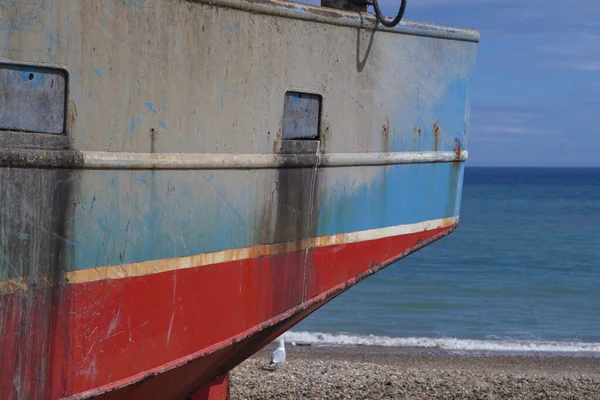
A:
282,92,321,139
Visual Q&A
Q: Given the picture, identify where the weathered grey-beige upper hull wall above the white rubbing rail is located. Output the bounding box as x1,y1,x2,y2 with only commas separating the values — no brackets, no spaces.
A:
0,0,476,154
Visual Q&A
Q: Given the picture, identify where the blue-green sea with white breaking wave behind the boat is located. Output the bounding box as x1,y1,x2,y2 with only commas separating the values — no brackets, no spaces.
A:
285,167,600,357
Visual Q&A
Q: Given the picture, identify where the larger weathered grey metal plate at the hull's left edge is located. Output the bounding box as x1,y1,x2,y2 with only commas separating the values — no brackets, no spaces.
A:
0,64,67,134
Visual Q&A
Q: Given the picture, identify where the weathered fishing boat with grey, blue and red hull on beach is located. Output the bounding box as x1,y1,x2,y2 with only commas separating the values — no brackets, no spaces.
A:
0,0,479,400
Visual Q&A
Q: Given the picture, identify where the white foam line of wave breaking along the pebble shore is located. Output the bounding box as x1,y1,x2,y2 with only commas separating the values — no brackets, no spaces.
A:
284,331,600,356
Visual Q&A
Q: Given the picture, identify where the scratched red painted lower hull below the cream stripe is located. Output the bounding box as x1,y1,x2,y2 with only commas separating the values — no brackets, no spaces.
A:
0,226,453,399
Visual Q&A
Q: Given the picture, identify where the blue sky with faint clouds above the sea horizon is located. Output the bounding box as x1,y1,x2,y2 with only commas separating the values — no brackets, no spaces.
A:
303,0,600,166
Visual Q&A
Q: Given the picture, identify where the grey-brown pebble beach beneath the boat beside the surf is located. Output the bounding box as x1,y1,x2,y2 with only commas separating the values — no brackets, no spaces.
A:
231,347,600,399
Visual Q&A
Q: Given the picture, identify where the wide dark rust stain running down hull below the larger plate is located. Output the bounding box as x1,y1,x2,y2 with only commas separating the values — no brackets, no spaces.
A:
0,165,78,398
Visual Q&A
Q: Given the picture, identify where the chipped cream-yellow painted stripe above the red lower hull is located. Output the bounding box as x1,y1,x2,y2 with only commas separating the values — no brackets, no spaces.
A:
0,216,459,295
